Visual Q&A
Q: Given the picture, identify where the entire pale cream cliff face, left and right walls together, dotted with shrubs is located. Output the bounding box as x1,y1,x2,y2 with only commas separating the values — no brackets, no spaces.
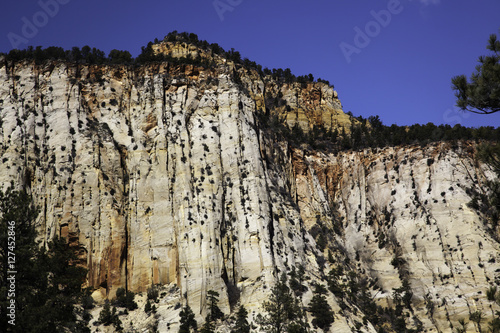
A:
0,57,500,332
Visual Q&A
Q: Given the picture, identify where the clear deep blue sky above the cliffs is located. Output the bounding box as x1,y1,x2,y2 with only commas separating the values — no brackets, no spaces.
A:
0,0,500,126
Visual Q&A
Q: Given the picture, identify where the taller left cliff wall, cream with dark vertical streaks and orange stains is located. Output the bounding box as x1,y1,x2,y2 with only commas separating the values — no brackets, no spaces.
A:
0,62,334,322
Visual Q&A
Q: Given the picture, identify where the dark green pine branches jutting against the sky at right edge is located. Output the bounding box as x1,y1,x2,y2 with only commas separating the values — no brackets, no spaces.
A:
451,28,500,114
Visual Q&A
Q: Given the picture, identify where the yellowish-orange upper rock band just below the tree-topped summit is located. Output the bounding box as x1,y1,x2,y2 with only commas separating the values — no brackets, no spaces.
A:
152,41,352,133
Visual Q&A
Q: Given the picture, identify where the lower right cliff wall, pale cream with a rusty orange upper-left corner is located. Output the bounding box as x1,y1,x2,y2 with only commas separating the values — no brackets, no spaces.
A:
295,143,500,332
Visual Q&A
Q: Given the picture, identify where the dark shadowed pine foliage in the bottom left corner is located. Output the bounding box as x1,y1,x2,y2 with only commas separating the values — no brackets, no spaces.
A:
0,188,89,332
